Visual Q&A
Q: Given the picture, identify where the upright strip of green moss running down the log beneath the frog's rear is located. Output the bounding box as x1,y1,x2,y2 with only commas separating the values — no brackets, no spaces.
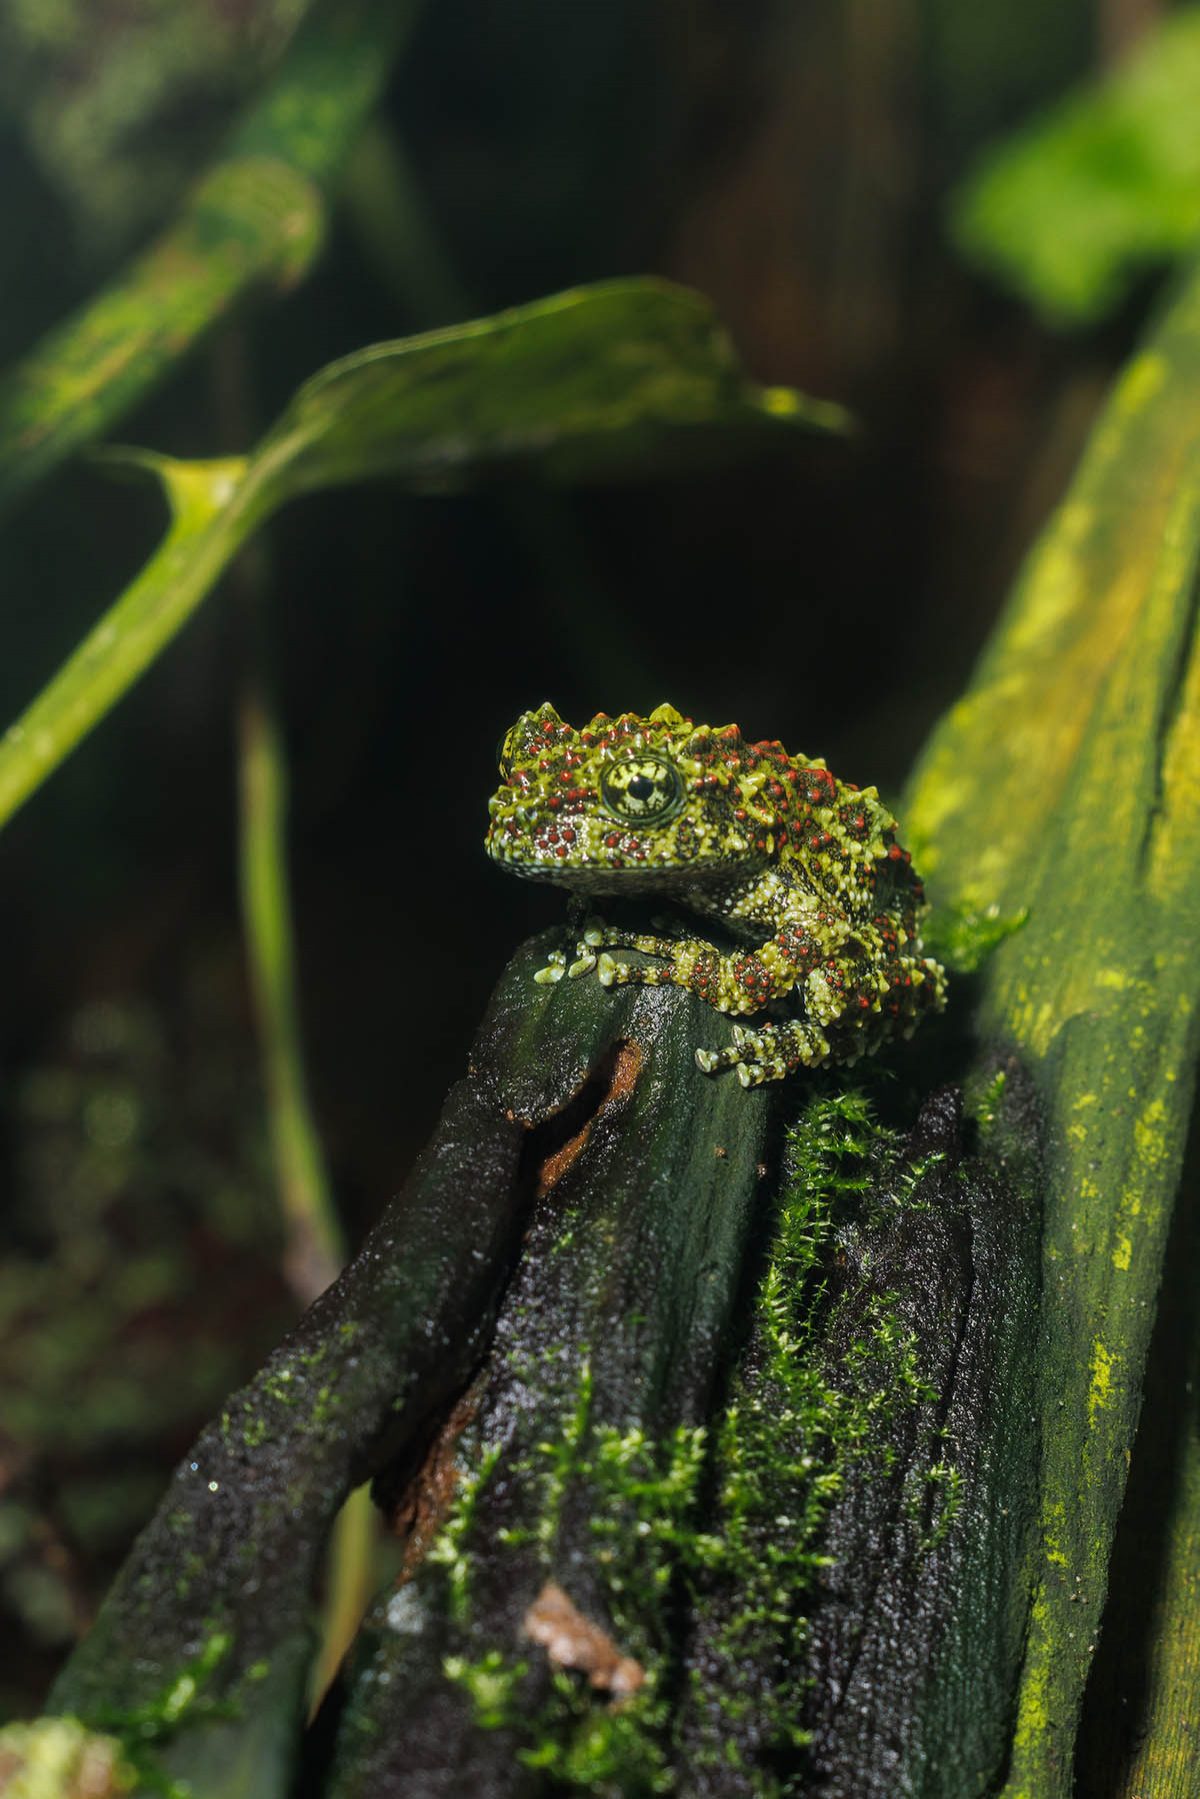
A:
689,1092,957,1795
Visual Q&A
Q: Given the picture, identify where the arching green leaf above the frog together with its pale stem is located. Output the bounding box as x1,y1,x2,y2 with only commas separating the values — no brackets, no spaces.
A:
0,281,847,824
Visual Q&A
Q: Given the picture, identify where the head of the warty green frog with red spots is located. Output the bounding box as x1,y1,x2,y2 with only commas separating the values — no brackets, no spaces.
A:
488,705,786,894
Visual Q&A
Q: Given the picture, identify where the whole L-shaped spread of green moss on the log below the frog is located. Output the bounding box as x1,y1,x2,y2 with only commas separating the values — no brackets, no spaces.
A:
430,1092,959,1795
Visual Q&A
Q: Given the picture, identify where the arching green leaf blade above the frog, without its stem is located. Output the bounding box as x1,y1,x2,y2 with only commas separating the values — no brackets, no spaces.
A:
255,269,849,498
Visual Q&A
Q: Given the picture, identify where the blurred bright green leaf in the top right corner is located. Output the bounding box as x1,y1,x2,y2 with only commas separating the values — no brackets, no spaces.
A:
952,7,1200,326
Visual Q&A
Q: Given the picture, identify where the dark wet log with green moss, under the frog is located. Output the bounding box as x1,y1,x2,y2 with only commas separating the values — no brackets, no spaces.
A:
44,935,1038,1799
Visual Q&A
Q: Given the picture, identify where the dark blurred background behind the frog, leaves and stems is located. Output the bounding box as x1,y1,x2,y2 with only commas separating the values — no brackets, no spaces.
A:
0,0,1151,1704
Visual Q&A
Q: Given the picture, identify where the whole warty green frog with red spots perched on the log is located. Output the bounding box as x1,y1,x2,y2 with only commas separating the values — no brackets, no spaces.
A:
488,703,945,1087
